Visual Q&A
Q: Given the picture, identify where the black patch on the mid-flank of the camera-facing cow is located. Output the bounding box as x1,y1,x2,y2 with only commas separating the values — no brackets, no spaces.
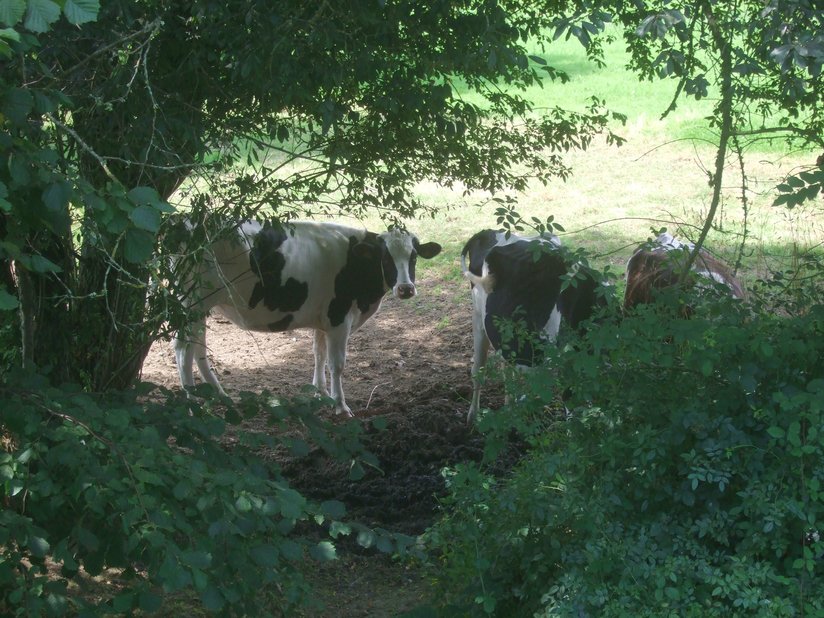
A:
249,223,309,312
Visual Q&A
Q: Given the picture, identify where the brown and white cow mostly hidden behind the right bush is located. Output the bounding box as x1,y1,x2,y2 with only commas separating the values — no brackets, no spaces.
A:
624,232,744,310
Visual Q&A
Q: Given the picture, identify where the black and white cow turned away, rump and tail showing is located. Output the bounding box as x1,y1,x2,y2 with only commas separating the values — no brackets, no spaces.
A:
461,230,606,423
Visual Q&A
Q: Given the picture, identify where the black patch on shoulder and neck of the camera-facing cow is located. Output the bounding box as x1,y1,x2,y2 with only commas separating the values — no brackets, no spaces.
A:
327,232,390,326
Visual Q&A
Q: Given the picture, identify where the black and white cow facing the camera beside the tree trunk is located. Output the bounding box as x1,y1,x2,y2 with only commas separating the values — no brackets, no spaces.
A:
175,221,441,416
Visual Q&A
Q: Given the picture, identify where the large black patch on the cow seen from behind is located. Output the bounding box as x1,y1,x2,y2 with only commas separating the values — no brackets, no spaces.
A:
484,241,567,365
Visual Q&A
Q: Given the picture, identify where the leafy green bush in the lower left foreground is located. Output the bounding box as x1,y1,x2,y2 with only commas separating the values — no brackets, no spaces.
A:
0,372,407,616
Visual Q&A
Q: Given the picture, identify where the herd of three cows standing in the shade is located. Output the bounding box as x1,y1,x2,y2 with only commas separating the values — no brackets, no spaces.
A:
175,221,743,422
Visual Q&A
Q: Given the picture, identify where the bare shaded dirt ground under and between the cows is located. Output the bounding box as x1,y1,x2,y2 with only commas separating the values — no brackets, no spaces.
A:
143,276,502,617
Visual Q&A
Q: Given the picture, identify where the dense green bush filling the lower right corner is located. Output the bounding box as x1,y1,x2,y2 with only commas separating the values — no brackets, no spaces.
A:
426,290,824,617
